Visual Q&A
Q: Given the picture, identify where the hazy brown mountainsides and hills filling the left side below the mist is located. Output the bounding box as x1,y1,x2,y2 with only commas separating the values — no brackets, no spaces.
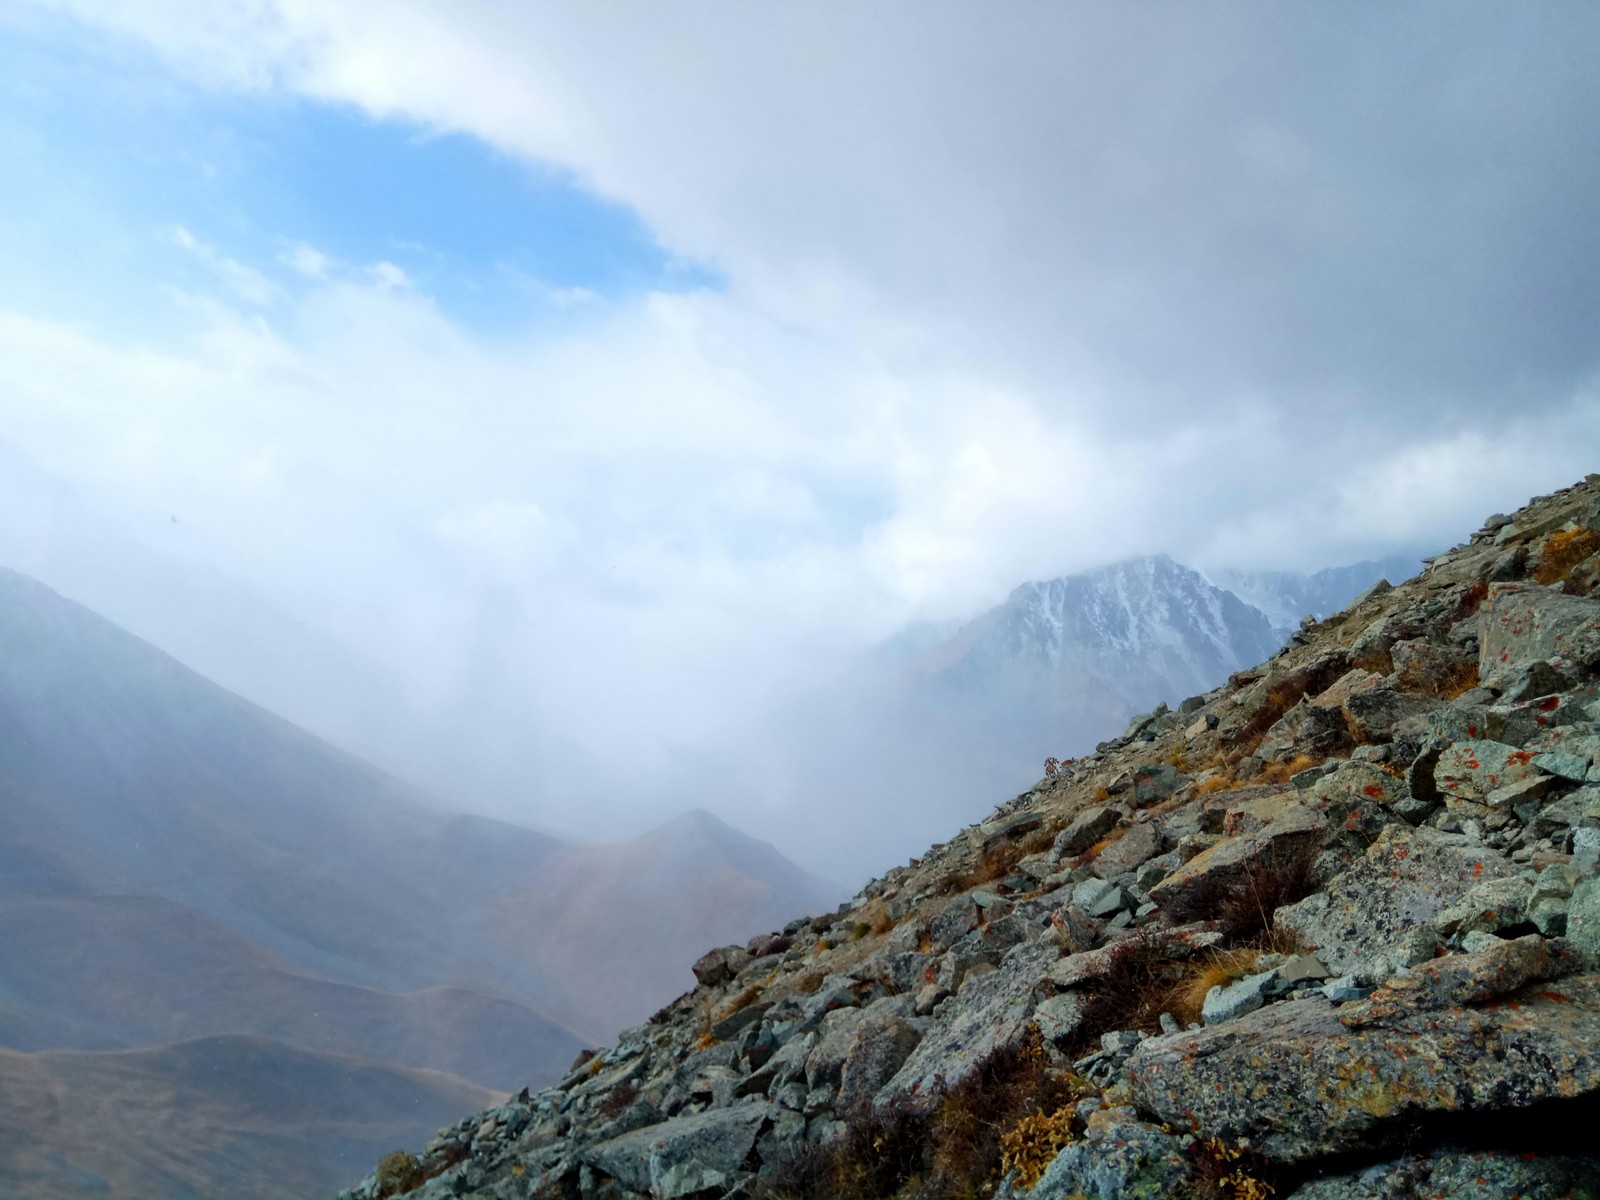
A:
0,571,837,1197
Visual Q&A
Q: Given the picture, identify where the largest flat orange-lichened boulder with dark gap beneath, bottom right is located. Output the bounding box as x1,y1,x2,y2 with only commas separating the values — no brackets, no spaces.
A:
1123,976,1600,1163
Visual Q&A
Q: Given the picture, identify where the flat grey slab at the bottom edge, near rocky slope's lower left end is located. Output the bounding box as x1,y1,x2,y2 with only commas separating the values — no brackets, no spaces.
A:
579,1102,771,1200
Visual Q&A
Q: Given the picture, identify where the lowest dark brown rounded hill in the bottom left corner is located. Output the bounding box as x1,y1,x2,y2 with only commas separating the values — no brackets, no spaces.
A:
0,1037,499,1200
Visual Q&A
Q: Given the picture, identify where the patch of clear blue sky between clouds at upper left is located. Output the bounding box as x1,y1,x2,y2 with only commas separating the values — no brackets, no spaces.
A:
0,12,720,336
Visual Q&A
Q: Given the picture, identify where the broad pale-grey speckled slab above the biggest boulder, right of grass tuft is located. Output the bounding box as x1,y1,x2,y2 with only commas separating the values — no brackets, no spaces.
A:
1274,826,1515,974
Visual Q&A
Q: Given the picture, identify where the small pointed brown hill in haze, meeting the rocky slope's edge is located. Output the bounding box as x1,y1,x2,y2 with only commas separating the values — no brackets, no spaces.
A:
496,811,840,1034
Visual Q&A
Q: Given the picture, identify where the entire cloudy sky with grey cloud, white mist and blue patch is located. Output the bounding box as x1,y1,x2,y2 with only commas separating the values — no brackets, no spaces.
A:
0,0,1600,883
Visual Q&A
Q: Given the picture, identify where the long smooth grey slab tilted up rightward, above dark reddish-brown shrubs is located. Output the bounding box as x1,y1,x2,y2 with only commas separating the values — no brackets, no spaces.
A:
874,942,1061,1109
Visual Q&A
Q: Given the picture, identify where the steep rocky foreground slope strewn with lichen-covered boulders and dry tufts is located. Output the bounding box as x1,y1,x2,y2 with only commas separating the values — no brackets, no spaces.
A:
344,475,1600,1200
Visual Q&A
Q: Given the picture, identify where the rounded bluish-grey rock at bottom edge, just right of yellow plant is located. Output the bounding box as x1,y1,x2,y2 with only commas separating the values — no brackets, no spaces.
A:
995,1107,1189,1200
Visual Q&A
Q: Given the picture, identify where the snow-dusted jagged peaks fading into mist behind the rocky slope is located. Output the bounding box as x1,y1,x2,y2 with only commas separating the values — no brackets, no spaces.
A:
755,555,1422,878
